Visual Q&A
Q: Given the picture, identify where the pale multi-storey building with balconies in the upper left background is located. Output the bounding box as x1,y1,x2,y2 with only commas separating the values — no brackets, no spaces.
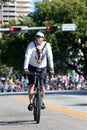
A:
0,0,32,25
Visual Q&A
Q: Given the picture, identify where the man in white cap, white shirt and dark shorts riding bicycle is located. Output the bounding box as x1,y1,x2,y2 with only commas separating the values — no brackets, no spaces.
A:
24,32,54,111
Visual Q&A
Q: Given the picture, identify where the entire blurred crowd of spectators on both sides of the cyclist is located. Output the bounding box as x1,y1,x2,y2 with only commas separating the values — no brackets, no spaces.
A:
0,72,87,92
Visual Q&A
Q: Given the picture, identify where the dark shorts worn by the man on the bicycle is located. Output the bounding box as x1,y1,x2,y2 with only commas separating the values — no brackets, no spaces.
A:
29,65,47,85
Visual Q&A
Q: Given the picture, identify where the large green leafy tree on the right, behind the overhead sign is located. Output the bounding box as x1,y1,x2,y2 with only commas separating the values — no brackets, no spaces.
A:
33,0,87,76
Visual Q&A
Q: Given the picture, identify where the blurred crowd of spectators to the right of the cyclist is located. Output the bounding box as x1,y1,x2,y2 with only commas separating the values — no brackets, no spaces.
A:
47,74,87,90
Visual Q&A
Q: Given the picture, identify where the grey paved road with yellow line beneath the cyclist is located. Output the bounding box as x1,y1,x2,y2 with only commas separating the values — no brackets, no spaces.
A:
0,93,87,130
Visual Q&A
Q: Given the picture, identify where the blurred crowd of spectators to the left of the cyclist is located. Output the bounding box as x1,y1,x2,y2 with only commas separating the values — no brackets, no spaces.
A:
0,72,29,92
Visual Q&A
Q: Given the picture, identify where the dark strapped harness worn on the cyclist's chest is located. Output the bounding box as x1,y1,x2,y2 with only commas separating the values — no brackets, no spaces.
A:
34,42,47,64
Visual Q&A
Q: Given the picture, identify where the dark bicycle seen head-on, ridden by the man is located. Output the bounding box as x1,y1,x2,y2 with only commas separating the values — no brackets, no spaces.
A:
29,72,46,123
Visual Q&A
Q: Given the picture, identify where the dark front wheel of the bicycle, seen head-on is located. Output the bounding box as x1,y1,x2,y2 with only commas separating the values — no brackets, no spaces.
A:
35,90,41,123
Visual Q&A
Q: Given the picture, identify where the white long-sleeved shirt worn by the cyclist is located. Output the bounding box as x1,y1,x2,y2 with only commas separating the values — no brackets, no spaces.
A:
24,41,54,69
